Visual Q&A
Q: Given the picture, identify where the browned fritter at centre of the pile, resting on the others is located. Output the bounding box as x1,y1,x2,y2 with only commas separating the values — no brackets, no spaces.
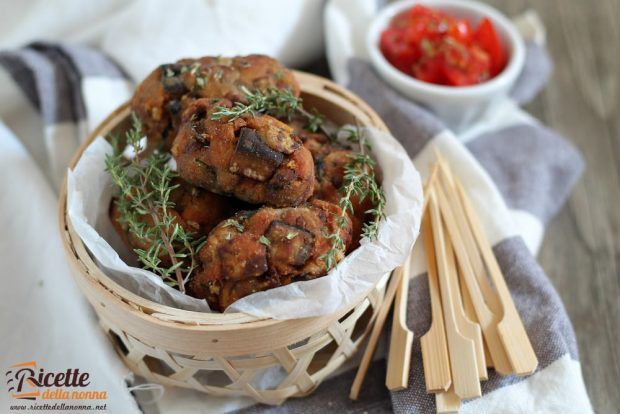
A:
172,99,314,207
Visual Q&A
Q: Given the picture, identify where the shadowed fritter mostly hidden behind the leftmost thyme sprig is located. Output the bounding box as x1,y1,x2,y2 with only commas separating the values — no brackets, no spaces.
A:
110,178,248,263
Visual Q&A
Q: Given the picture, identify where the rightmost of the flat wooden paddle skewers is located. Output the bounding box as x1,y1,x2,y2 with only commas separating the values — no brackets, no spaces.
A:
456,181,538,375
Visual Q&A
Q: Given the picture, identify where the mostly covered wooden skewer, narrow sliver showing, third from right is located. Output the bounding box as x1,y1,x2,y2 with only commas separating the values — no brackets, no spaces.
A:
446,234,489,380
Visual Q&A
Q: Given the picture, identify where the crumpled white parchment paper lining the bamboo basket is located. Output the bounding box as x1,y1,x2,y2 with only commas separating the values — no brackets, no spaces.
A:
67,129,423,319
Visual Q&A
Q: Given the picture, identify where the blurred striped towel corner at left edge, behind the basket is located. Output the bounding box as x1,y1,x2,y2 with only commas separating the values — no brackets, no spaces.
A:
0,42,133,189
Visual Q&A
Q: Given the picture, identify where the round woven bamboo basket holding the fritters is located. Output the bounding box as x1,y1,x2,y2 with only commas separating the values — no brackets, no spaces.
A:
59,72,387,404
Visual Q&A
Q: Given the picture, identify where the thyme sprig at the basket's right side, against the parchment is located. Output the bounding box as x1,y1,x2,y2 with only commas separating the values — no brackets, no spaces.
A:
321,126,385,271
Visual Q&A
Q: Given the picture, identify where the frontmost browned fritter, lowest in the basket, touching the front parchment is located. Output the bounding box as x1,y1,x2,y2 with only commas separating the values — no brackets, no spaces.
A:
189,200,351,310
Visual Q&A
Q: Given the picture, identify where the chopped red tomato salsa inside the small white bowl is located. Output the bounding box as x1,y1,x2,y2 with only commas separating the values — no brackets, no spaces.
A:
379,5,506,86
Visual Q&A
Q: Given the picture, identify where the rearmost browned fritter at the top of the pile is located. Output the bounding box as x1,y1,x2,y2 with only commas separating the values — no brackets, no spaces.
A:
131,55,299,148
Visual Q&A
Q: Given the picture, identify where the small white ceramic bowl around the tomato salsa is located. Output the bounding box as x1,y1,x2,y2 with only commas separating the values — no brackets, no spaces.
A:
366,0,525,131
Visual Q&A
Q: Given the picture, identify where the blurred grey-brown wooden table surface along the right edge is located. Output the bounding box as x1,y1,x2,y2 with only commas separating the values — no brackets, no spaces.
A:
489,0,620,413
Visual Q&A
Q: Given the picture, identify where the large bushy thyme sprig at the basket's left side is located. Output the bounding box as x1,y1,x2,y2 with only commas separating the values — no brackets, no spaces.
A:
105,113,204,292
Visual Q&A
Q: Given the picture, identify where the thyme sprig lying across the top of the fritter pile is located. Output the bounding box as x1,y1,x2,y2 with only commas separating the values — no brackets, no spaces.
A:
211,86,330,136
